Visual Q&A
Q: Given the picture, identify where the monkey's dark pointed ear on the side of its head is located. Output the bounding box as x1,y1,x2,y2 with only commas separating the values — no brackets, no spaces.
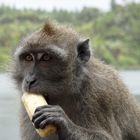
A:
77,39,90,62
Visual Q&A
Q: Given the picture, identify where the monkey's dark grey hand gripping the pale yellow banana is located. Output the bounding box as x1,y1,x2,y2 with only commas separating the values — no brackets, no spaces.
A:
32,105,74,139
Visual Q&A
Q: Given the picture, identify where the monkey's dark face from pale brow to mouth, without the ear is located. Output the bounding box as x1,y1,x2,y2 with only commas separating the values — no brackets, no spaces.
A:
13,44,70,98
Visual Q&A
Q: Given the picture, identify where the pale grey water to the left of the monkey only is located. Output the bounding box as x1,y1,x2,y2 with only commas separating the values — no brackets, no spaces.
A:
0,74,20,140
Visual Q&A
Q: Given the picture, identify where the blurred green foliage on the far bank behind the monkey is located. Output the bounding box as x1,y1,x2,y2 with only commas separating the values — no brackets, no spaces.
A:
0,3,140,70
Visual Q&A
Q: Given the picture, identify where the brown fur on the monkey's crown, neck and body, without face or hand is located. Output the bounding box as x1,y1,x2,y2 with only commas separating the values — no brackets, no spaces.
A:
12,22,140,140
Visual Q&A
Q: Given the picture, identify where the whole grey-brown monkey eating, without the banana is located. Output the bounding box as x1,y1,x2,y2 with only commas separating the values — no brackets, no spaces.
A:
12,21,140,140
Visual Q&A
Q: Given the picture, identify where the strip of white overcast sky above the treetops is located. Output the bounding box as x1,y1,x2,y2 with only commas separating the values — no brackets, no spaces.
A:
0,0,140,10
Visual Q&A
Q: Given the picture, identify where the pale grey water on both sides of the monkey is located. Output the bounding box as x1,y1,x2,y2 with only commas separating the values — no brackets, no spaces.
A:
0,71,140,140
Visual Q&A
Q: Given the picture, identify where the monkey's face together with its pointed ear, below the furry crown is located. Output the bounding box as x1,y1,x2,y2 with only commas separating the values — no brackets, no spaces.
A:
15,40,90,98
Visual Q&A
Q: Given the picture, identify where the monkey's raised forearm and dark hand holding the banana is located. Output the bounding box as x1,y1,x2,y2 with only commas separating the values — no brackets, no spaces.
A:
32,105,113,140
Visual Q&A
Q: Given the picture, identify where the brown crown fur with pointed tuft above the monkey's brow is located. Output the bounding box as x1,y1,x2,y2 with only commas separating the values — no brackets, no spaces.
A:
23,20,82,48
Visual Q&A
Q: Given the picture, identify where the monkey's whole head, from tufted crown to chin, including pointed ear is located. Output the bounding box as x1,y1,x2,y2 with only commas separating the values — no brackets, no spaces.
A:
14,23,90,101
